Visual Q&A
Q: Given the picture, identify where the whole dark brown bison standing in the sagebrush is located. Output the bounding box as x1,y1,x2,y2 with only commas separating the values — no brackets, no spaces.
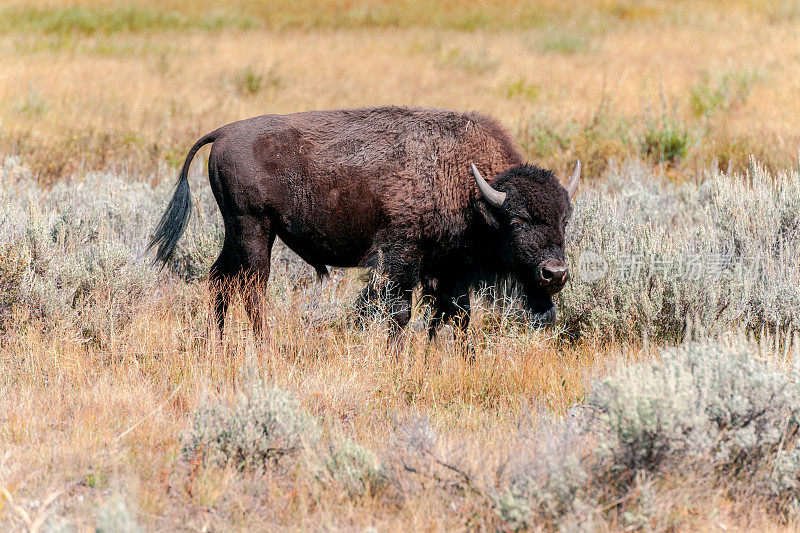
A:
150,106,580,336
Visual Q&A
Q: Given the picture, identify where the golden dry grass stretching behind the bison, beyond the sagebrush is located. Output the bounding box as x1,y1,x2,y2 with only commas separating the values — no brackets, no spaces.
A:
0,0,800,181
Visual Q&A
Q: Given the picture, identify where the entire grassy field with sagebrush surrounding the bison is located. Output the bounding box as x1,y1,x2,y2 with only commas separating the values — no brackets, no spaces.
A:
0,0,800,531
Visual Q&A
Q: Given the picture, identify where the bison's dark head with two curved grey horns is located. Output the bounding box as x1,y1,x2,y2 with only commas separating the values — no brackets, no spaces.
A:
472,161,581,325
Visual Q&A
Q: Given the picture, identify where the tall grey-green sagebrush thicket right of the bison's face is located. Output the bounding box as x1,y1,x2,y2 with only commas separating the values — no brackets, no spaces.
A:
558,163,800,342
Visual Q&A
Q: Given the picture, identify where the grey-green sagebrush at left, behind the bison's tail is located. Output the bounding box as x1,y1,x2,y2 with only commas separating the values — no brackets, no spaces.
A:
0,158,221,344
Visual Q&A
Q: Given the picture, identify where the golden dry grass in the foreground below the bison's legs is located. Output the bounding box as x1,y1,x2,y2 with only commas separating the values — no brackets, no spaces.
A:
0,280,619,530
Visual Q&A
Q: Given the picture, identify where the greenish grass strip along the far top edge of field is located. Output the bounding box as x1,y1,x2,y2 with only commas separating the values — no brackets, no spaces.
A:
0,0,783,35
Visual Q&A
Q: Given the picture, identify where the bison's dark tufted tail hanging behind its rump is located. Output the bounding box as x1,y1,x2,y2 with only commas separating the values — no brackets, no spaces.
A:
147,131,217,266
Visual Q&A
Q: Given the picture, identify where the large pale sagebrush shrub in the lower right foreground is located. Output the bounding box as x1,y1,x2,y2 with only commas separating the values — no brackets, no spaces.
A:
587,344,800,482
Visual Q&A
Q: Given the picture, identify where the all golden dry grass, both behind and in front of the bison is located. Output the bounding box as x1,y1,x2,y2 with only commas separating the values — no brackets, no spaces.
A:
0,0,800,531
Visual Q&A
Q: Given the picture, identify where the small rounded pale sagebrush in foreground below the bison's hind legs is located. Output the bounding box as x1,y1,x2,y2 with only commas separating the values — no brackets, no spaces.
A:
182,381,320,469
